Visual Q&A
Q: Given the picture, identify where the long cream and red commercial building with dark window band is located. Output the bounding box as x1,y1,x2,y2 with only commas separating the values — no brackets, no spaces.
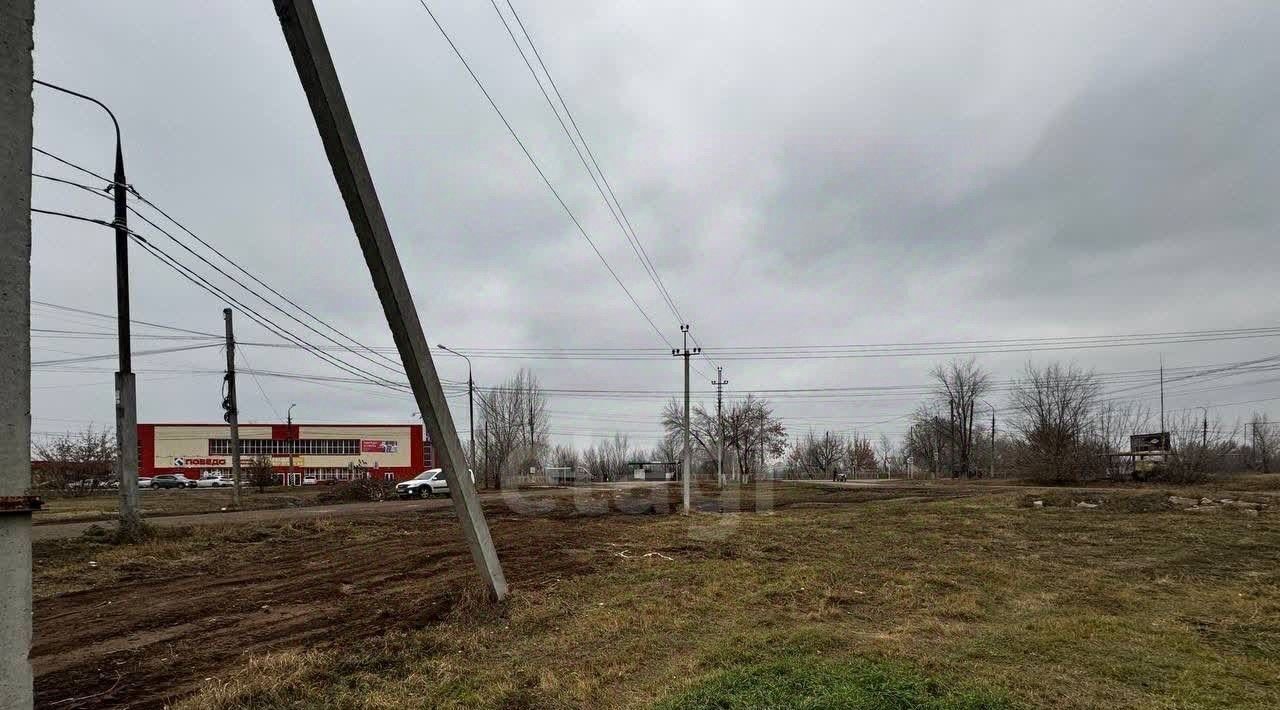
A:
138,423,436,485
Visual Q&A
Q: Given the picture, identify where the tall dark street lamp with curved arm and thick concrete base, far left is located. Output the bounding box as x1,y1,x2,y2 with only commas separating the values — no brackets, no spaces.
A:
32,79,141,539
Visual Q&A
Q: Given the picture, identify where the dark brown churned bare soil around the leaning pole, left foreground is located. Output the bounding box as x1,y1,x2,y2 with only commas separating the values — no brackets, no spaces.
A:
32,512,645,707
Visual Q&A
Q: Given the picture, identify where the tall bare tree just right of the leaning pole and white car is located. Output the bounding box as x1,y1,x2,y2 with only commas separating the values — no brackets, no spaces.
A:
476,368,550,487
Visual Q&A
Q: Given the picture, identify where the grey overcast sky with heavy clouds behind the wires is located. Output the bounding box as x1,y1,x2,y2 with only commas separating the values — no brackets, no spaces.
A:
32,0,1280,444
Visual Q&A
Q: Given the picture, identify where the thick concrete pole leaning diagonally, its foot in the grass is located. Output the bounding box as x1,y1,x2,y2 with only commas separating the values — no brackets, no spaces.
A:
274,0,507,600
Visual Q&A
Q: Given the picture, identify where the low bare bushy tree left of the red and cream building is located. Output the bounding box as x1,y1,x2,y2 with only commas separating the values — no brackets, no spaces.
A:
32,425,115,495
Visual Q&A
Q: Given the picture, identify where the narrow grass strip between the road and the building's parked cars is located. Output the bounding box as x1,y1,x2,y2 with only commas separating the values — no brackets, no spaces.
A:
33,486,324,525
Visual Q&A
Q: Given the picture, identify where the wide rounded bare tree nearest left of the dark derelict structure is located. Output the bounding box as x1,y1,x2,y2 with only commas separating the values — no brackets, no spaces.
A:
1010,363,1101,481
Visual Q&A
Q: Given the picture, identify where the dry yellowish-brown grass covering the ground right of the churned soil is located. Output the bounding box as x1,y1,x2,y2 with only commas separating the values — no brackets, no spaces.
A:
162,493,1280,710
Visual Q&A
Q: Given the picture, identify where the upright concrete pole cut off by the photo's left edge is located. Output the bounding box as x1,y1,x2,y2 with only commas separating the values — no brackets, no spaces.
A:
0,0,38,710
